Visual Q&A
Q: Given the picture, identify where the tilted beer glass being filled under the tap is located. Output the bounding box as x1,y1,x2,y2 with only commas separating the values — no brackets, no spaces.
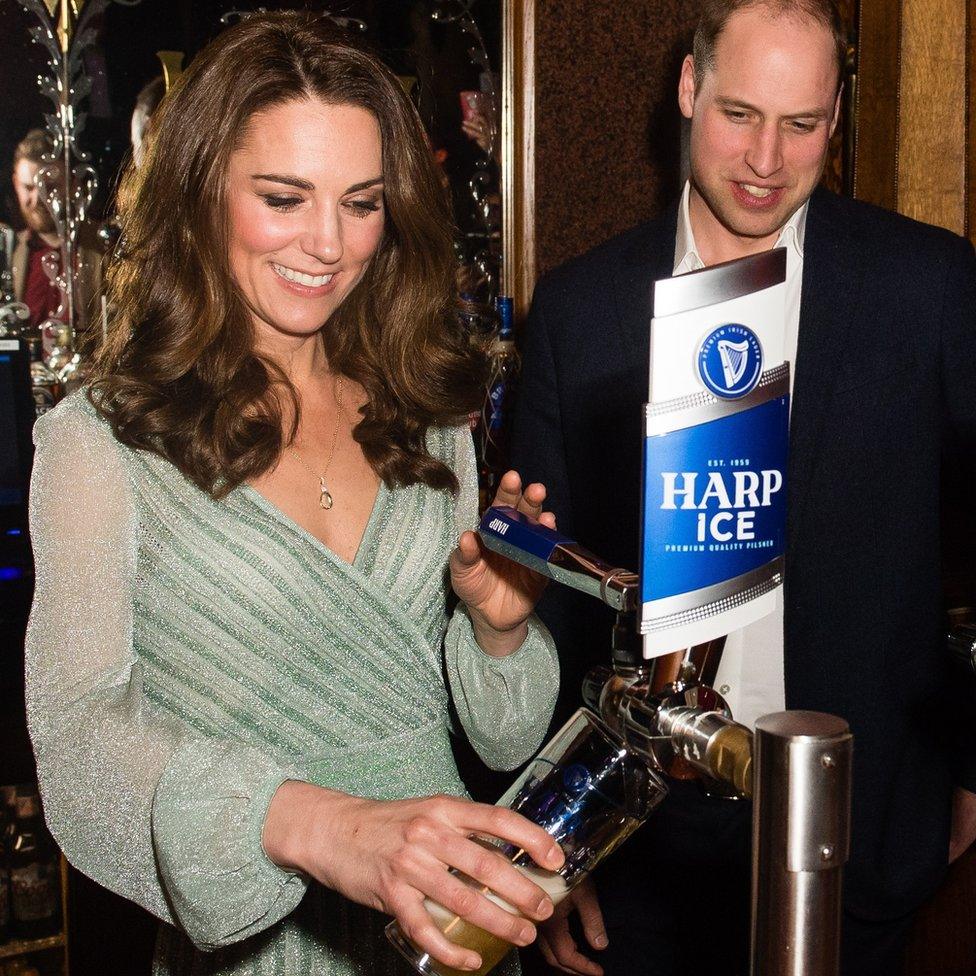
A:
386,708,667,976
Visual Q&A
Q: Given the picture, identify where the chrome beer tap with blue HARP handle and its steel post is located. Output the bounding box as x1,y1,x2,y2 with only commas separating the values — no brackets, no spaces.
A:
480,507,856,976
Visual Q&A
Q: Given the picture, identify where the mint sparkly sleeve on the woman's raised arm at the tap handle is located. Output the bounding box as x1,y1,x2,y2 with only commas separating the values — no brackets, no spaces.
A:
444,429,559,769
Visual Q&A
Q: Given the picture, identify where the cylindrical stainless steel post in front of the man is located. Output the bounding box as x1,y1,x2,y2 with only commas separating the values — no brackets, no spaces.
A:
751,711,853,976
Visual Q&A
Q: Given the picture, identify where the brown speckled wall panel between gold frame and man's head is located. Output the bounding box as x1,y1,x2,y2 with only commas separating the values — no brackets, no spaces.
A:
535,0,698,274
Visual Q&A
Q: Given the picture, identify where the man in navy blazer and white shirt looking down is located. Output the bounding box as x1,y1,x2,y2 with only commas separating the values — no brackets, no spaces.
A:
512,0,976,976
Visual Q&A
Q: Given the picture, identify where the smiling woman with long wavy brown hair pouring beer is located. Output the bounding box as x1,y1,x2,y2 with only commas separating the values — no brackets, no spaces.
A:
22,13,562,974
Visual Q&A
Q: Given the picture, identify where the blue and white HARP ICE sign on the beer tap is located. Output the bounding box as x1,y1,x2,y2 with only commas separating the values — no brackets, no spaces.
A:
640,248,790,658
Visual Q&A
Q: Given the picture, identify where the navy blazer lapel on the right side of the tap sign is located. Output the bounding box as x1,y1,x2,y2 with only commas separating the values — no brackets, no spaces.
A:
787,189,862,538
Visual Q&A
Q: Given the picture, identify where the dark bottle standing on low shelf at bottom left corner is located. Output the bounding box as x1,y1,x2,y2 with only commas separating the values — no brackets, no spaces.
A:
9,786,61,939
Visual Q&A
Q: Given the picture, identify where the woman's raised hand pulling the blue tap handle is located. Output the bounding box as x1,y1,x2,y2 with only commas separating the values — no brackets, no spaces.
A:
450,471,556,657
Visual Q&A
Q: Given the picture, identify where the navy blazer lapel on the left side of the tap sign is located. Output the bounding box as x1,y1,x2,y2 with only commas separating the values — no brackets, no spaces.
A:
612,202,678,366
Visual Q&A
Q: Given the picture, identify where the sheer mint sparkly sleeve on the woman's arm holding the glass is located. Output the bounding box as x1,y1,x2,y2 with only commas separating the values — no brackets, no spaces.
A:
26,403,306,948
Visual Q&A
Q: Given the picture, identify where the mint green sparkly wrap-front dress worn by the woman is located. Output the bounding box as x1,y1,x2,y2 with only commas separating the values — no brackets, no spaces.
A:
27,395,558,976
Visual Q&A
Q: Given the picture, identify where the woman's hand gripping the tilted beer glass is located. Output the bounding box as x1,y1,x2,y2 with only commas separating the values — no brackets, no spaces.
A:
263,780,563,969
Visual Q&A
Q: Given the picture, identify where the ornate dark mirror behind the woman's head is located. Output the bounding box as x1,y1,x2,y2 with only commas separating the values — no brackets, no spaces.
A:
0,0,502,362
